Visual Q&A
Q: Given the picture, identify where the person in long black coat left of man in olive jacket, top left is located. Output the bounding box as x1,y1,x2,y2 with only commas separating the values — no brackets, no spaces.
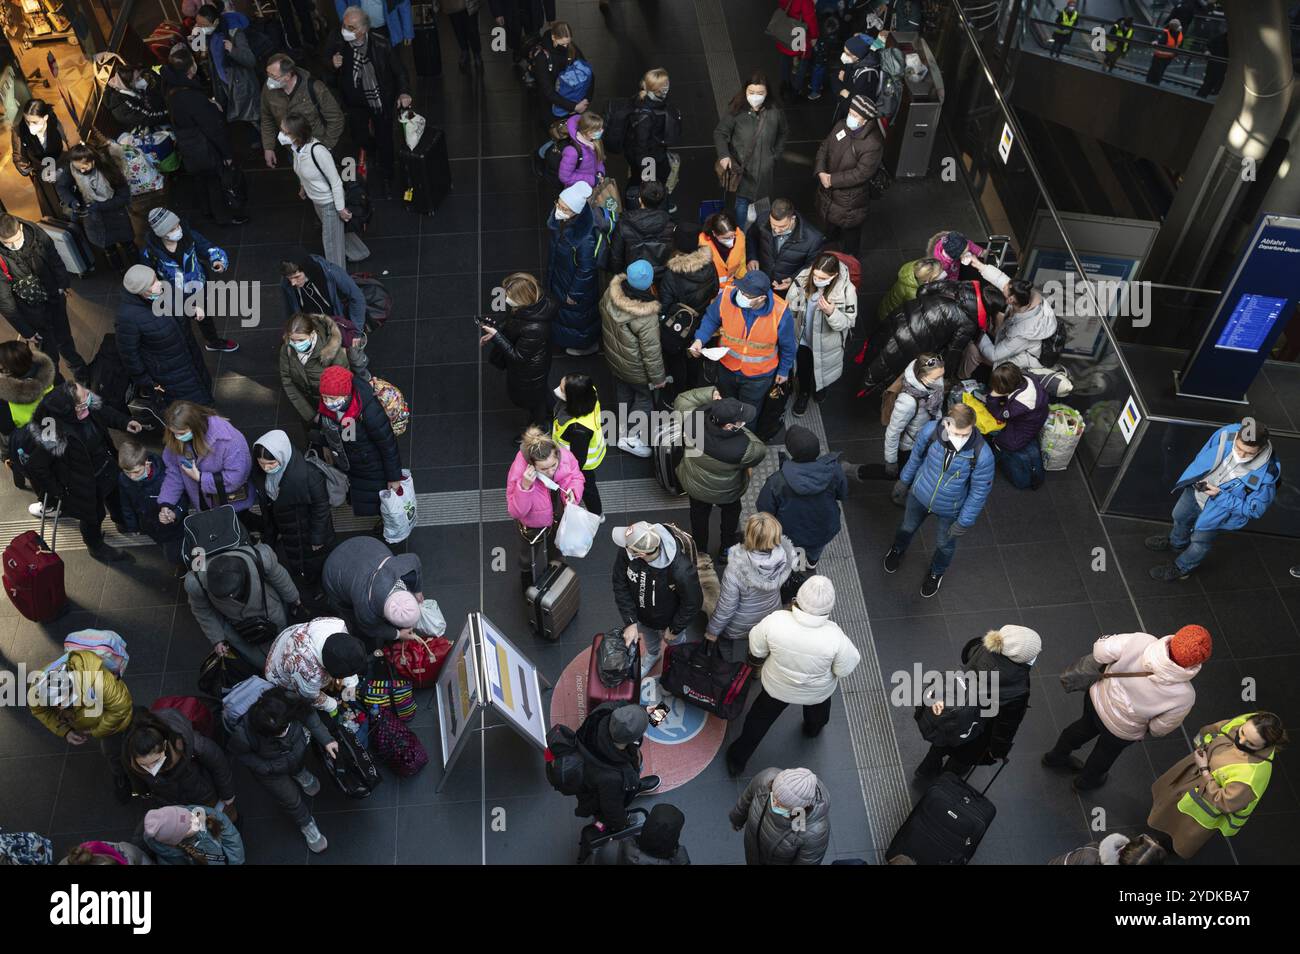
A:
161,48,248,225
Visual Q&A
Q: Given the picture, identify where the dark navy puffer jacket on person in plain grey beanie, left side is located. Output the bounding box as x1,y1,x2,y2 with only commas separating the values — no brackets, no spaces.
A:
113,292,213,407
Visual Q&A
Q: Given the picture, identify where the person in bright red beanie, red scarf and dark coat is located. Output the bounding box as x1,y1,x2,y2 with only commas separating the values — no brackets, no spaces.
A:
316,365,402,517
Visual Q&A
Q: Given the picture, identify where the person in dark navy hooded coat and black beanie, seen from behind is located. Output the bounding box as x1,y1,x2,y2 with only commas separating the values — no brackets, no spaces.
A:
755,424,849,571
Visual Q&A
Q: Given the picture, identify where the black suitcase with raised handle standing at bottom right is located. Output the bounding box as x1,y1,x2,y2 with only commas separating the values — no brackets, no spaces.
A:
885,759,1006,864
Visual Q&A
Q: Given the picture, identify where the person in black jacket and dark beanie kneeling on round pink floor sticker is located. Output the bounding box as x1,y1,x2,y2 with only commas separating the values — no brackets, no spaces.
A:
573,702,659,842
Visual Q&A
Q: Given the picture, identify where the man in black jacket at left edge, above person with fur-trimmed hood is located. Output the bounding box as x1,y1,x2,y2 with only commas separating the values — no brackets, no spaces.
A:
0,214,86,382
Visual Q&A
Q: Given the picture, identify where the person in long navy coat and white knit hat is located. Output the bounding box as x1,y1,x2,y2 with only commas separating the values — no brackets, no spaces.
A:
546,182,607,356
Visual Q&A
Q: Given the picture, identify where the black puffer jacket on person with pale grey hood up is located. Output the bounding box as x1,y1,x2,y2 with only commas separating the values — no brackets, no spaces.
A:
252,450,334,581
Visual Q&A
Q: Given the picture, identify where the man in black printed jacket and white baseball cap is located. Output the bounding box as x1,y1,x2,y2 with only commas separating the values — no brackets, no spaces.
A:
612,520,705,677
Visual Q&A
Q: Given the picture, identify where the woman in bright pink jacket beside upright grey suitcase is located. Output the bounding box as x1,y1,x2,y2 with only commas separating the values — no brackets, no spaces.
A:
506,428,586,590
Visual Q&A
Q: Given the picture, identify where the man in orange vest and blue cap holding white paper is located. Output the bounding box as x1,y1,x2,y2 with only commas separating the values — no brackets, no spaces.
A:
690,272,796,409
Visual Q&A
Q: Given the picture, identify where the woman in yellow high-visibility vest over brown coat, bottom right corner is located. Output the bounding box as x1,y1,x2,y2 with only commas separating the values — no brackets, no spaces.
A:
1147,712,1287,858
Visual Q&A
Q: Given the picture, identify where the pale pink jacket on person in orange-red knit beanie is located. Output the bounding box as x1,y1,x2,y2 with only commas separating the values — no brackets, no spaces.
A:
1088,633,1201,742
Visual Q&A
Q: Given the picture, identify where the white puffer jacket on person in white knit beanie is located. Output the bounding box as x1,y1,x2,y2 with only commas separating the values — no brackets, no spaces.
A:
749,606,862,706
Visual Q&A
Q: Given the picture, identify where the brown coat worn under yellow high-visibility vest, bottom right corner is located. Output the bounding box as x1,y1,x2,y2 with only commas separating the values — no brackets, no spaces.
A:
1147,719,1273,858
